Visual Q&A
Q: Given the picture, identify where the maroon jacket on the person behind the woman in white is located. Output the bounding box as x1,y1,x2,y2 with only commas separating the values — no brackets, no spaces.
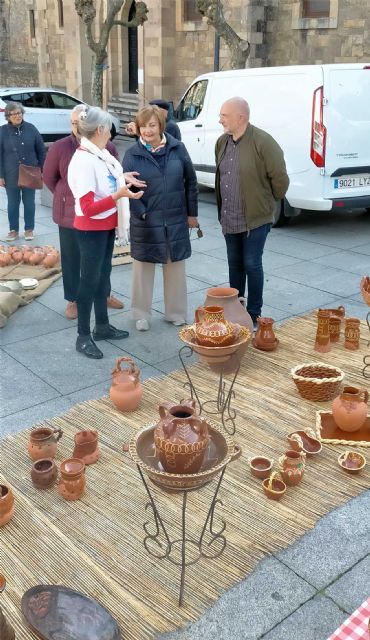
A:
44,134,119,229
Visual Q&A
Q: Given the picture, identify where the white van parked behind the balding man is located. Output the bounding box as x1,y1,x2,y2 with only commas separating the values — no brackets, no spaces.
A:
176,63,370,224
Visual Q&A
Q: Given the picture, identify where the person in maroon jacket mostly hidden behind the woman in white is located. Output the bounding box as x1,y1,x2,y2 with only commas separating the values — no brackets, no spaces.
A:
43,104,139,320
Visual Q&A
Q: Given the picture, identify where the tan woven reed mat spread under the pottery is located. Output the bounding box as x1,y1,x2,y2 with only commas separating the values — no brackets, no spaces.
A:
0,313,370,640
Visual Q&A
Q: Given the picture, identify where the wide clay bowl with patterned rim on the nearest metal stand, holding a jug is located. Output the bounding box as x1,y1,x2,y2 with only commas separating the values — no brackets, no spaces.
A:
129,422,241,491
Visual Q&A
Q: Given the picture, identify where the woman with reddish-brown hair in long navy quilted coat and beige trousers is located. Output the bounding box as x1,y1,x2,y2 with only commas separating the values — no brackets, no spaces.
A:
122,105,198,331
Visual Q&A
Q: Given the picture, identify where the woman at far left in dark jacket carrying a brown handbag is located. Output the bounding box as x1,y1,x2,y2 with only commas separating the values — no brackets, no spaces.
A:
0,102,46,241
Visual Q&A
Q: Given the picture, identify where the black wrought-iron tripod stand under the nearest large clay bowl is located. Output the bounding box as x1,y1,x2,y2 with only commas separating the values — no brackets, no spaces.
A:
137,465,226,607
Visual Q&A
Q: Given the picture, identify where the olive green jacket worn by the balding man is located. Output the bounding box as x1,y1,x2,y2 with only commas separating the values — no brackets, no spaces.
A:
215,124,289,229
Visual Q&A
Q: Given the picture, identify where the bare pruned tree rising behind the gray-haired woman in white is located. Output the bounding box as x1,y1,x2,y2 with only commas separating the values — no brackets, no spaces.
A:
75,0,148,106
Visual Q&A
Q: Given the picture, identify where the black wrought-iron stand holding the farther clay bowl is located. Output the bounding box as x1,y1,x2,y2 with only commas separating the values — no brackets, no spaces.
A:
179,345,240,436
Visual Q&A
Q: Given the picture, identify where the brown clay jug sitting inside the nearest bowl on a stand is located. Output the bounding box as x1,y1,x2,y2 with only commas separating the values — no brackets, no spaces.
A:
154,400,209,474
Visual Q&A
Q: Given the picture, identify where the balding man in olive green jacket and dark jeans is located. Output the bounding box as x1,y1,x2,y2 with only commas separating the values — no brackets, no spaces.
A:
215,98,289,326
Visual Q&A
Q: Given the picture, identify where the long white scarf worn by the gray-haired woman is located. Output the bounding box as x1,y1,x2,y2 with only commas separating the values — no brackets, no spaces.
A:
80,137,130,246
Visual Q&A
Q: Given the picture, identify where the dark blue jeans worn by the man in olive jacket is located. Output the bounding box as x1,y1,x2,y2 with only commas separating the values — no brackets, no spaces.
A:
225,224,271,320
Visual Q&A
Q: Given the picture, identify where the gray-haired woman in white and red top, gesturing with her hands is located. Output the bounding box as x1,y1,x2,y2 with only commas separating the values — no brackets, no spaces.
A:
68,107,143,358
